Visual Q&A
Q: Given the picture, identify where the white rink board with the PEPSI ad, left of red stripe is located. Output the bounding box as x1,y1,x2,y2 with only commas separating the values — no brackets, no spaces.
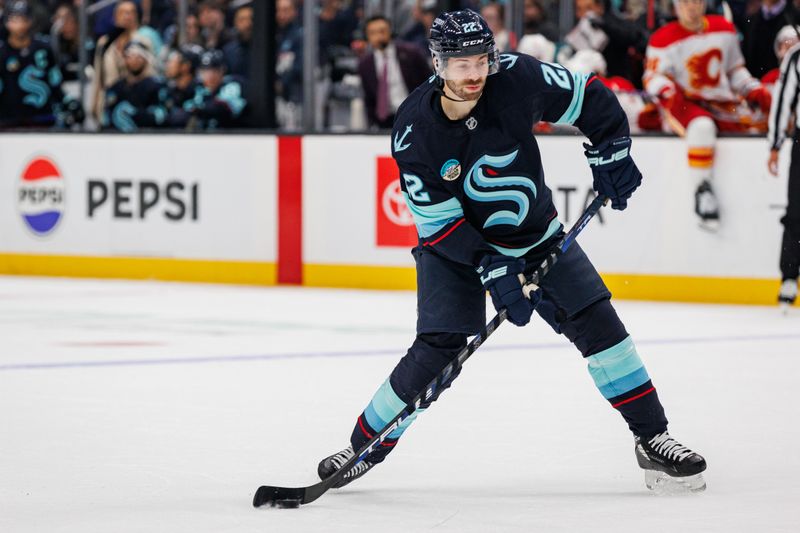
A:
0,134,277,261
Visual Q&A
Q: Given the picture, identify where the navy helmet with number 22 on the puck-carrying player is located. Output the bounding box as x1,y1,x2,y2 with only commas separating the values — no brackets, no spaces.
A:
430,9,500,79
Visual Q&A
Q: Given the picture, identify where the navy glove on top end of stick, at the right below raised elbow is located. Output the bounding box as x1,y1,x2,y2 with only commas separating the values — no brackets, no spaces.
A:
583,137,642,211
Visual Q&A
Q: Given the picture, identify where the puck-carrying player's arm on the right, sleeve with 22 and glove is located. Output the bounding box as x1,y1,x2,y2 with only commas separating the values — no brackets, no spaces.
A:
538,55,642,210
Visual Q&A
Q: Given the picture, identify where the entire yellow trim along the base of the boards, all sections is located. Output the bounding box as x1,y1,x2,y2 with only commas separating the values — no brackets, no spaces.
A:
0,254,800,305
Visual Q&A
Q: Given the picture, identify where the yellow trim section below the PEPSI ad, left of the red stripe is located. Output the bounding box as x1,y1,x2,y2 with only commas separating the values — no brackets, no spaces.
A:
0,254,277,285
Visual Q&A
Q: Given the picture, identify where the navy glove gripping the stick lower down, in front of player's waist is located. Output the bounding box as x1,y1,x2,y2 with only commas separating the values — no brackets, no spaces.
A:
478,255,542,326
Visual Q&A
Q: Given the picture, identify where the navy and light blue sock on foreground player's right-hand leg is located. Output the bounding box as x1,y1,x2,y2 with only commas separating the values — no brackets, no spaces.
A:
586,336,667,438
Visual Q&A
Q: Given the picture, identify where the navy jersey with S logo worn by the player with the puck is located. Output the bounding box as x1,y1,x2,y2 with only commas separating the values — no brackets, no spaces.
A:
392,54,629,266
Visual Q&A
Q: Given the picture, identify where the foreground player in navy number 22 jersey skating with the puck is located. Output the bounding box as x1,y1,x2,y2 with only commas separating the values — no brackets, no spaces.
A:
318,10,706,490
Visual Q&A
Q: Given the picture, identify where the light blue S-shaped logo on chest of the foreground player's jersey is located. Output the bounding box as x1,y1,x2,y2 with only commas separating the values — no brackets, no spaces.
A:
464,150,536,229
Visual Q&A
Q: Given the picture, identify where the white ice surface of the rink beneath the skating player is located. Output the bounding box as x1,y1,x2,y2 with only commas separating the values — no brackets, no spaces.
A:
0,277,800,533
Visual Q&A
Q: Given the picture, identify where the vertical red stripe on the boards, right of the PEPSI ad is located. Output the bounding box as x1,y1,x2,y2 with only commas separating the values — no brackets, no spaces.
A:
278,136,303,285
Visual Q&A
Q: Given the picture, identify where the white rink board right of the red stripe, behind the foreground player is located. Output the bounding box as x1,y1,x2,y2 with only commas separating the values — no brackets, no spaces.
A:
303,136,789,278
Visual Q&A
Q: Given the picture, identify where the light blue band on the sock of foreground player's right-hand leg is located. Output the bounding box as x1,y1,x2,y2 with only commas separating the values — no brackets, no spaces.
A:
586,335,650,398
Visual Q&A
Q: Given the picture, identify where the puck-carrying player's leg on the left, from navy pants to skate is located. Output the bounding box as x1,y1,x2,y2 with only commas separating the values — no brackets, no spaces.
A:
317,248,486,488
